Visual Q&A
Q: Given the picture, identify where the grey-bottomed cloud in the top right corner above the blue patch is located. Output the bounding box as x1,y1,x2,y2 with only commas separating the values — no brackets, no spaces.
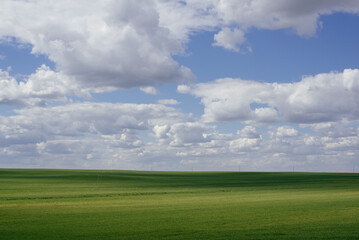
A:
216,0,359,36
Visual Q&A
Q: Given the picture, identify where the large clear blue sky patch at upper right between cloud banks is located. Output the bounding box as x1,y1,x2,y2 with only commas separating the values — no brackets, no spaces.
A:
175,13,359,82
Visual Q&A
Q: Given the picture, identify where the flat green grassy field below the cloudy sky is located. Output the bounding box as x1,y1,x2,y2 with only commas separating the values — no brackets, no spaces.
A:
0,169,359,240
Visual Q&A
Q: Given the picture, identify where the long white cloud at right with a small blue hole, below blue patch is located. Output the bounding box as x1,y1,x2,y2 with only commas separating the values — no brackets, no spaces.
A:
178,69,359,123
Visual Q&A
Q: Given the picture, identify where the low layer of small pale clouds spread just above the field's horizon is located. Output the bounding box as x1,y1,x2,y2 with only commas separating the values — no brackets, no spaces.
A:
0,102,359,171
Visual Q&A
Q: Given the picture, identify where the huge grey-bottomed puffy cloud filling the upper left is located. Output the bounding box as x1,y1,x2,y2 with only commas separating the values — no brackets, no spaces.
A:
0,0,194,88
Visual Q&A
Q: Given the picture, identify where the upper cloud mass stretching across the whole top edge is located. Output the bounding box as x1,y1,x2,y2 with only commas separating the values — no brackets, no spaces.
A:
0,0,359,97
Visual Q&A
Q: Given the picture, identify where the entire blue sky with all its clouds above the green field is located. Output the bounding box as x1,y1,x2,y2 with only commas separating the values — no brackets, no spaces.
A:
0,0,359,172
